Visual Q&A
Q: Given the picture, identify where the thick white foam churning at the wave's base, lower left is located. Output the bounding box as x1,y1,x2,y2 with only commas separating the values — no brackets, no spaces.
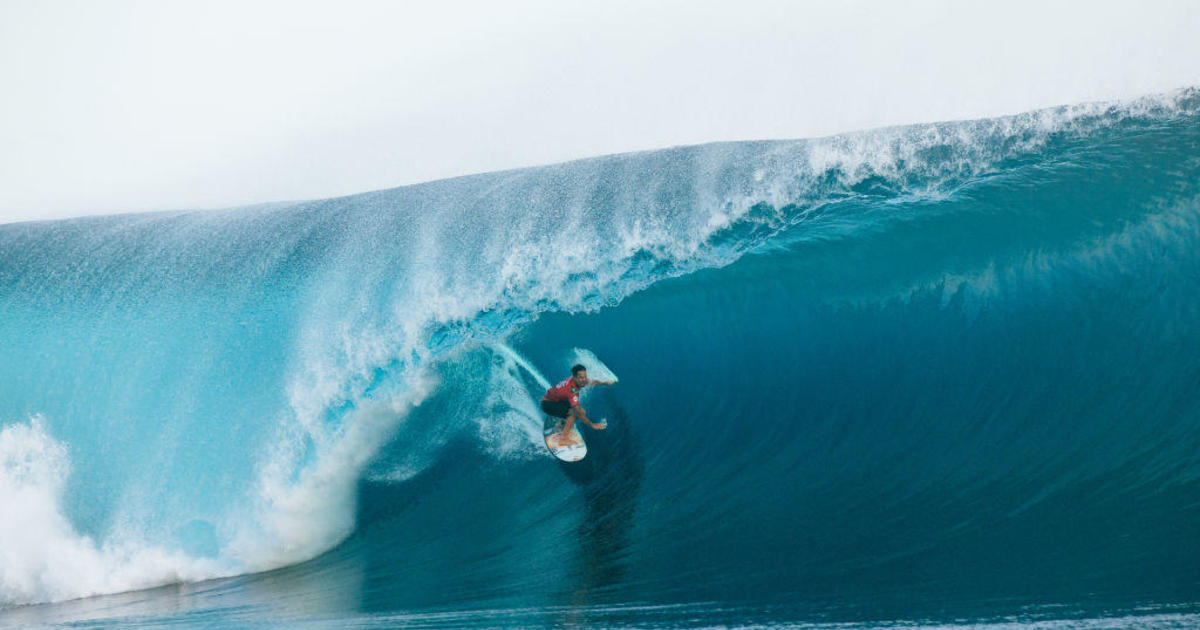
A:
0,348,446,605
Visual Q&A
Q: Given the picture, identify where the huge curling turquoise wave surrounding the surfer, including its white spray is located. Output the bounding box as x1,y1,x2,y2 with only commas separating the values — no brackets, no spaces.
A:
0,90,1200,625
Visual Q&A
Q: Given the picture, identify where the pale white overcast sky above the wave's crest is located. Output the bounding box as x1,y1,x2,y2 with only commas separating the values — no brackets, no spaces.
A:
0,0,1200,223
